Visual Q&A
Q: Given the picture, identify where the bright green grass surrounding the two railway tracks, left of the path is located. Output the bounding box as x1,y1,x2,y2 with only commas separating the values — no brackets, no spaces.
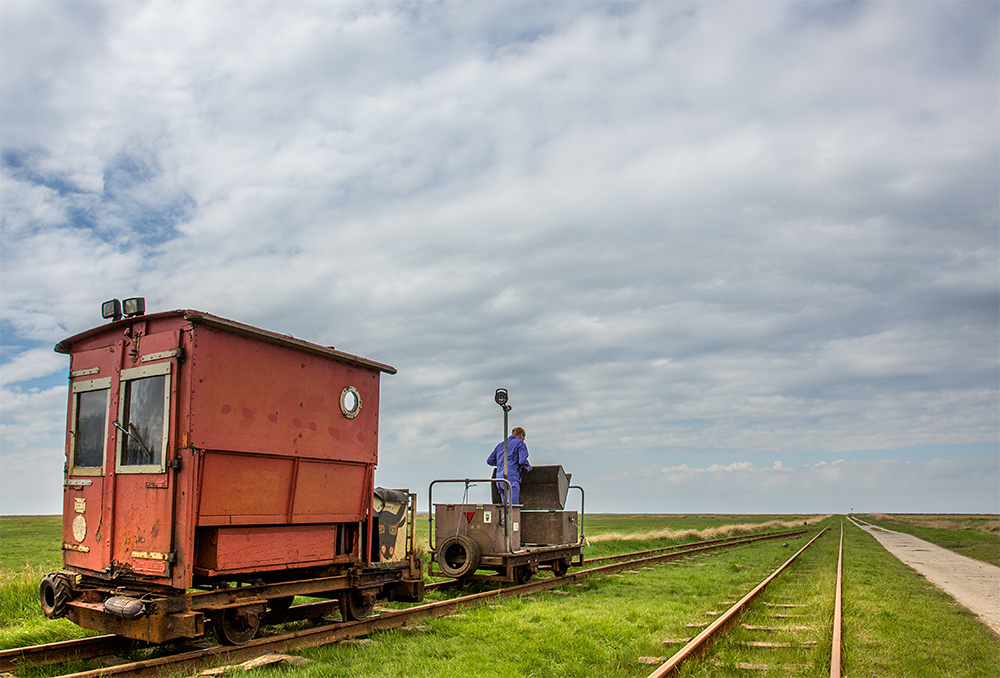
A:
0,515,1000,678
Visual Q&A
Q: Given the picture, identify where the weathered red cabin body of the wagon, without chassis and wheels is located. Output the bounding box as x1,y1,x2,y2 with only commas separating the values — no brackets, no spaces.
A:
56,311,395,589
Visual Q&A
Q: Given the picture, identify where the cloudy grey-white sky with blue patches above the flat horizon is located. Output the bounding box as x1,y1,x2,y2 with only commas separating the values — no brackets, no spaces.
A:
0,0,1000,514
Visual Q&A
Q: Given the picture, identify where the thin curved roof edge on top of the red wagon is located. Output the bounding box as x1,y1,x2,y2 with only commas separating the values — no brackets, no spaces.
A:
55,310,396,374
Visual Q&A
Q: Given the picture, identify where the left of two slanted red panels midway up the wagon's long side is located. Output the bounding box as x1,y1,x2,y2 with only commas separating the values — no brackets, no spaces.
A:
194,452,295,525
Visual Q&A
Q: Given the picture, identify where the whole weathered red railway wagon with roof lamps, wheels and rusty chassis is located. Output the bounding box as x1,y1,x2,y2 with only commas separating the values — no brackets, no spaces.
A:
39,300,423,643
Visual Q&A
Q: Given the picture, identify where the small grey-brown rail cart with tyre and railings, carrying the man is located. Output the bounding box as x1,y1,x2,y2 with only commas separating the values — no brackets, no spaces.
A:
427,466,584,584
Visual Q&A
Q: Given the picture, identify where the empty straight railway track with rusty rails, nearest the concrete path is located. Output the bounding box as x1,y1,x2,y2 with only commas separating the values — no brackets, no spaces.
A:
649,523,844,678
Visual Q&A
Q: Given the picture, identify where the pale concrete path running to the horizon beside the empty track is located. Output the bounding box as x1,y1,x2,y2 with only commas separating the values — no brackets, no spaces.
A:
850,518,1000,635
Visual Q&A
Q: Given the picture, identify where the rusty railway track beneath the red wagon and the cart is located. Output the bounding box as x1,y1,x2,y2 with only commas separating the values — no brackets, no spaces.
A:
0,528,810,678
